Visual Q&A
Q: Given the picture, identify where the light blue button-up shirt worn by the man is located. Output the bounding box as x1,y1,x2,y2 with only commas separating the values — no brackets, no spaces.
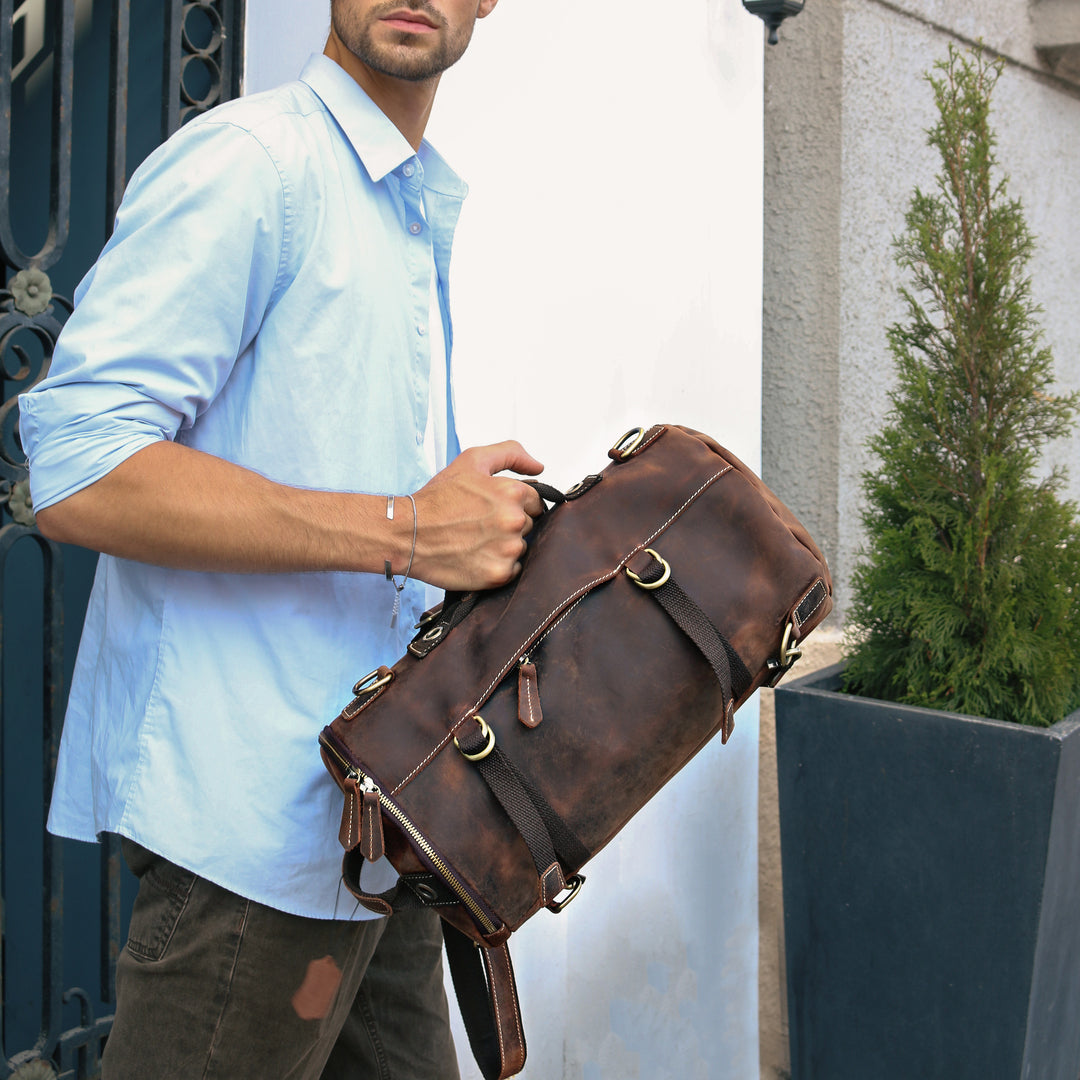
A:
21,56,465,918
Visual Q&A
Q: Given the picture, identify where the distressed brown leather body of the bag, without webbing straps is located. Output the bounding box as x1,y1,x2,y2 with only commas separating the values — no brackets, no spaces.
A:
317,427,832,940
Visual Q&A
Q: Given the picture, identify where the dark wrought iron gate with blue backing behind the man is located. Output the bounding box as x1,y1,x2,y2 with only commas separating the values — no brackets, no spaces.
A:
0,0,244,1080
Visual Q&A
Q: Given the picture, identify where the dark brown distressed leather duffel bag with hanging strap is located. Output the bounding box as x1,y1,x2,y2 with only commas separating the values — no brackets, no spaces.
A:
320,426,832,1080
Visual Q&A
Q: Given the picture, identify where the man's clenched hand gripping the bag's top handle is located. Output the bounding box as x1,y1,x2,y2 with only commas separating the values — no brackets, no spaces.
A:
408,442,543,590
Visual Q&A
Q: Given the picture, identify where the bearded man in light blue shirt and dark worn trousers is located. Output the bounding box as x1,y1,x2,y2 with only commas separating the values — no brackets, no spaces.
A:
22,0,542,1080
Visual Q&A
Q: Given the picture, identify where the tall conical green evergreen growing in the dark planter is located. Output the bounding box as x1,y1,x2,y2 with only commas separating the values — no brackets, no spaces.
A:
845,48,1080,726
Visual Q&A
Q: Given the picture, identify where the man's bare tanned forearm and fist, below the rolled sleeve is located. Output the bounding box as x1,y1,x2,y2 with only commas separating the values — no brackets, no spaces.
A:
38,442,542,589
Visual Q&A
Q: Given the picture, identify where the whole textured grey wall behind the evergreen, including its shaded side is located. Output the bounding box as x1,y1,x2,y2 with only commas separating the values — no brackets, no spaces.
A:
759,0,1080,1080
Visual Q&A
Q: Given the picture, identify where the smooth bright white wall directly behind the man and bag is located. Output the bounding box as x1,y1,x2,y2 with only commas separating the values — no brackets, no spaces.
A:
246,0,761,1080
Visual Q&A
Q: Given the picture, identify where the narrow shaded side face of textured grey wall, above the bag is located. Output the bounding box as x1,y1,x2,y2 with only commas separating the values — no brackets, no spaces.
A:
761,3,843,604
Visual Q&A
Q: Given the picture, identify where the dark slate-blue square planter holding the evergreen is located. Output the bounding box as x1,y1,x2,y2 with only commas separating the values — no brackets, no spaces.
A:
775,665,1080,1080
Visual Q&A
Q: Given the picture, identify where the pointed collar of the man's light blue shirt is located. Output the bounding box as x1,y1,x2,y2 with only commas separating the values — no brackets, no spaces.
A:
300,53,469,199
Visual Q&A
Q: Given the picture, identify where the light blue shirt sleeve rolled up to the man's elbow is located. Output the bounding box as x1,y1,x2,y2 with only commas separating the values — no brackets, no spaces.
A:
19,121,287,510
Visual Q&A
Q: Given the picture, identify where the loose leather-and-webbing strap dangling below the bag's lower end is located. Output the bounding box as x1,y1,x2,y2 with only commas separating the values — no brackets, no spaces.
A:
443,921,526,1080
